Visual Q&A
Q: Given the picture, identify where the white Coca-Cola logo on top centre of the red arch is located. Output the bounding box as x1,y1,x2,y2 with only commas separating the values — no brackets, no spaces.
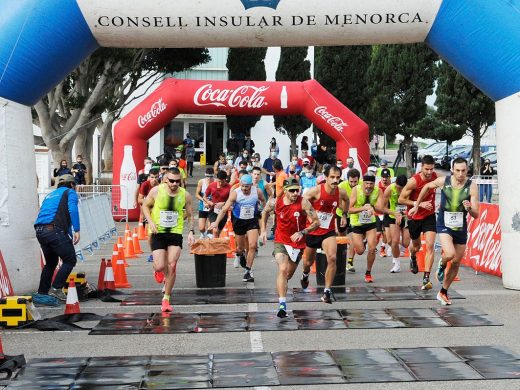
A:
193,84,269,108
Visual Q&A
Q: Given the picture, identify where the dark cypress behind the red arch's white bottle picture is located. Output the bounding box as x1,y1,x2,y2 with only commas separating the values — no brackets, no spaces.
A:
274,47,311,154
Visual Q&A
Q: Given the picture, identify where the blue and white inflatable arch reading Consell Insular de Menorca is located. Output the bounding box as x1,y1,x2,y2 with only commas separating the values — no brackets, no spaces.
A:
0,0,520,292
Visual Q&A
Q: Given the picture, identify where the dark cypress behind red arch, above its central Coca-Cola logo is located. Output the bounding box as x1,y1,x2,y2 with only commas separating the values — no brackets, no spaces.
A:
226,47,267,134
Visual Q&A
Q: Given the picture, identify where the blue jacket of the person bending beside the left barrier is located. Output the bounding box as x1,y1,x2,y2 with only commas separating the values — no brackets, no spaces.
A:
34,187,80,234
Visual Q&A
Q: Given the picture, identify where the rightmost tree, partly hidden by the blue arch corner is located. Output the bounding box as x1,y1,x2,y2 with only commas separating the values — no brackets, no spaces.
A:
435,61,495,174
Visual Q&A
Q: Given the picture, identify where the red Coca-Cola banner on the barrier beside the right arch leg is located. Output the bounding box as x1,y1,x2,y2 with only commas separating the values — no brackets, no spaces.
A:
462,203,502,277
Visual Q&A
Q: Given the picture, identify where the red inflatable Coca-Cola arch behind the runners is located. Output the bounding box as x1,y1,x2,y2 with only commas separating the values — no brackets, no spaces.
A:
113,79,370,220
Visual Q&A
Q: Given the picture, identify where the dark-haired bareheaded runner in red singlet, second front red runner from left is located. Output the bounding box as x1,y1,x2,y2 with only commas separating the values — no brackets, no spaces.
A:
300,165,348,304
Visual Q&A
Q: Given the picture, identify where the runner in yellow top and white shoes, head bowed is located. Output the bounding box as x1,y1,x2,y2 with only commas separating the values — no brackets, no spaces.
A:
383,175,410,273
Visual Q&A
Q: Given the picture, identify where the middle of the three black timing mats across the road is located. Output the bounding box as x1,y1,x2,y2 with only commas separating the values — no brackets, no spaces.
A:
89,307,502,335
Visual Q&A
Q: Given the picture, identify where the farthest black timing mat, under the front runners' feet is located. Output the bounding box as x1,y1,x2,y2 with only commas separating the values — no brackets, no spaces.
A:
121,286,464,306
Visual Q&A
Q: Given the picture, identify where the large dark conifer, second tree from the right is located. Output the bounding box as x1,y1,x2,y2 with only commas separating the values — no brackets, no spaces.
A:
367,43,437,172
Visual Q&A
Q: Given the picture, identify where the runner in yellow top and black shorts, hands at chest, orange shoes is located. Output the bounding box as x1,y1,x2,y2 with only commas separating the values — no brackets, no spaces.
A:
349,174,383,283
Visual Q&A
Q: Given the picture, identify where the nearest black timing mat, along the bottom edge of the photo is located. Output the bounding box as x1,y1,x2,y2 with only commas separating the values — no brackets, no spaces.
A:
8,346,520,390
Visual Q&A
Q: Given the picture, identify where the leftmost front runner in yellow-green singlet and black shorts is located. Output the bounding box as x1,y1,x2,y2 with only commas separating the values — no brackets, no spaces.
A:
143,168,195,312
